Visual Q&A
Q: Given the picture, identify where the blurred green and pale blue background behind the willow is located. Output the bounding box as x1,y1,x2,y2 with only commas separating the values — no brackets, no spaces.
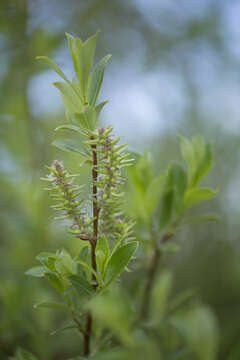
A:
0,0,240,360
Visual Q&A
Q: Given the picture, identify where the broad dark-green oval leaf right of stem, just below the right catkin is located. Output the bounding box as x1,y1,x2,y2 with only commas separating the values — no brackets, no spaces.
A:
104,241,138,286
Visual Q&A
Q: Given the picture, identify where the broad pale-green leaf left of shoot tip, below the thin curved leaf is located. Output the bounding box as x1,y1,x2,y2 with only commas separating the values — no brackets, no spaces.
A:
53,81,83,115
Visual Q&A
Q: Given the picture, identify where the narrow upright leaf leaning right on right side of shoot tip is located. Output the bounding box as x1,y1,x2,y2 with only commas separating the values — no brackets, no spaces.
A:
88,55,111,105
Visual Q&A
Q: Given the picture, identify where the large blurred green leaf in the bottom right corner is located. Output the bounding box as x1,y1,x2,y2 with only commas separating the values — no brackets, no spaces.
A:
171,306,219,360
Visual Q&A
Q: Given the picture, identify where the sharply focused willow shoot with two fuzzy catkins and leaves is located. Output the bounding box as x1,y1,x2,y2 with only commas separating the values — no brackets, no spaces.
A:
27,32,137,355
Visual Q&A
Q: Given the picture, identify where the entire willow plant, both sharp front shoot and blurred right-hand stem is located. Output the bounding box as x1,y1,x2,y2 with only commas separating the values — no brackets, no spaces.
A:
23,32,220,360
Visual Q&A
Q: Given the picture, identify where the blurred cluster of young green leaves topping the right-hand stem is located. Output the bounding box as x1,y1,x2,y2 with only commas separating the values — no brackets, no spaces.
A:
126,136,218,245
